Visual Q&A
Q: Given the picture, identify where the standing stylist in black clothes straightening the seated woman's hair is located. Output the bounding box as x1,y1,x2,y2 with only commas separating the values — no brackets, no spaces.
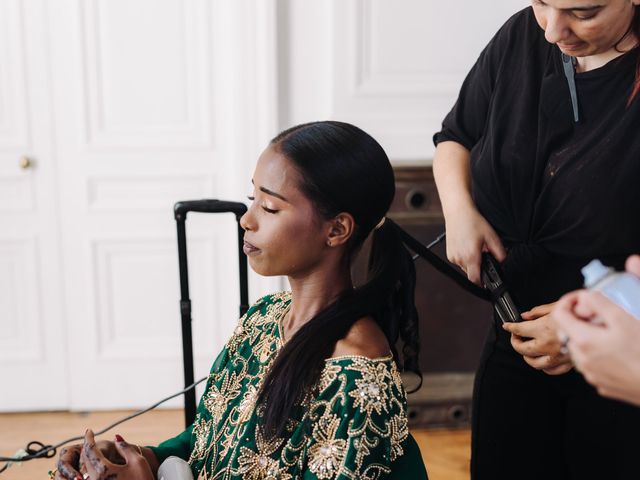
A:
433,0,640,480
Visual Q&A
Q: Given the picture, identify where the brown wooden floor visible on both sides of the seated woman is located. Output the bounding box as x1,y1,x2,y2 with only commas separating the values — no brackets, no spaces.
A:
0,410,470,480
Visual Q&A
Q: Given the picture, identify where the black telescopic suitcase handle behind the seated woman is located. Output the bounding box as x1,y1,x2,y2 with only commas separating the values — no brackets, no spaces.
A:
173,199,249,427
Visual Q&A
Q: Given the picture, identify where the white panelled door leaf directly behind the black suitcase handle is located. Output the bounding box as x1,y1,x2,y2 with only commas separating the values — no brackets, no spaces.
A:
43,0,278,409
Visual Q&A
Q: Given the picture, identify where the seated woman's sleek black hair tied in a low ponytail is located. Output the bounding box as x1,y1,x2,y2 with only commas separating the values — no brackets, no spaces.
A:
259,121,422,437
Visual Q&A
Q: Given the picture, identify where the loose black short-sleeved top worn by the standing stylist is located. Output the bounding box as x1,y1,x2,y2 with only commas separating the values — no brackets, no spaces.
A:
434,7,640,310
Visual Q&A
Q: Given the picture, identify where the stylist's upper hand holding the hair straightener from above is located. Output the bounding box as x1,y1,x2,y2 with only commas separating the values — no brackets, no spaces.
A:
445,205,506,285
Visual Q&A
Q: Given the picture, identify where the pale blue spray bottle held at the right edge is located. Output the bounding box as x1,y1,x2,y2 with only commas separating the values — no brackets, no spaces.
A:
582,260,640,320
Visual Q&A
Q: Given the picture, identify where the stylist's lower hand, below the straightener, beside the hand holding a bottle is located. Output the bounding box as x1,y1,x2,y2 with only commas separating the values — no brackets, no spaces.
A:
502,302,573,375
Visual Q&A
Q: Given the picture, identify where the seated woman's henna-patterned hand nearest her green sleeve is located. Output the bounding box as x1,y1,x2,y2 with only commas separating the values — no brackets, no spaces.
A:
80,430,155,480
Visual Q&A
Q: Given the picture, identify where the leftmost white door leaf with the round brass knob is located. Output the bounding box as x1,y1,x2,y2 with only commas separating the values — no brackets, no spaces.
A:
0,0,68,411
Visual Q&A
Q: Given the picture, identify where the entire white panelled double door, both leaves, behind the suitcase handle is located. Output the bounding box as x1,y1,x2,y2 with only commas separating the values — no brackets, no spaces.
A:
0,0,281,411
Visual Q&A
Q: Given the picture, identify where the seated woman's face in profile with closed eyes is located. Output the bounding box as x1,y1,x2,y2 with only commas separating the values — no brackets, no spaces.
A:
240,146,330,277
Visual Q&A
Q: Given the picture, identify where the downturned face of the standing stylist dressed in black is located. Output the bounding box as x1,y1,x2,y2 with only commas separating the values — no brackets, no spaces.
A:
532,0,640,57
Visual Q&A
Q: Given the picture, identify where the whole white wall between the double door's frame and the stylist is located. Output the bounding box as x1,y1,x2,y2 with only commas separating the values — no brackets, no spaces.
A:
279,0,530,164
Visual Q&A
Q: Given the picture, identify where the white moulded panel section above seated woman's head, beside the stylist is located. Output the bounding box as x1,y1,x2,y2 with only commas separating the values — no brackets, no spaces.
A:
328,0,530,161
